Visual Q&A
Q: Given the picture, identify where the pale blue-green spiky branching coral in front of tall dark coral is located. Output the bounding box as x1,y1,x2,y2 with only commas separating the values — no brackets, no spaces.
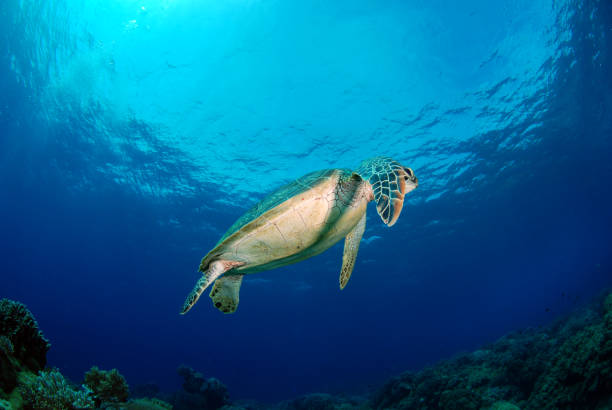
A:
19,369,94,410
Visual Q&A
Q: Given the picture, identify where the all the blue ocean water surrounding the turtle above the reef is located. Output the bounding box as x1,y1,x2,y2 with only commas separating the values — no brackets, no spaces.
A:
0,0,612,401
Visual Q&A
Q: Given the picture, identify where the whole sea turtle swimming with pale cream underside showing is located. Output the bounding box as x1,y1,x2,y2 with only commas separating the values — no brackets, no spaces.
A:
181,157,418,314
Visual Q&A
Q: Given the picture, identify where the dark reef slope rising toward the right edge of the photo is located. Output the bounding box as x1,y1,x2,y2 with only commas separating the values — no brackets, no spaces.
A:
371,293,612,409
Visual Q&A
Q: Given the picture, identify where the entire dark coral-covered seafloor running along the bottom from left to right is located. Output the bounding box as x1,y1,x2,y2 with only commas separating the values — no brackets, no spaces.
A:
0,292,612,410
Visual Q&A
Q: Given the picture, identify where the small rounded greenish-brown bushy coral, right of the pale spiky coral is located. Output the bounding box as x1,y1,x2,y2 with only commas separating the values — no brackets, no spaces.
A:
84,366,130,407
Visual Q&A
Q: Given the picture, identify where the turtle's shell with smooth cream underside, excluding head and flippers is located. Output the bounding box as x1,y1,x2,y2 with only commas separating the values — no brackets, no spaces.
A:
200,169,362,273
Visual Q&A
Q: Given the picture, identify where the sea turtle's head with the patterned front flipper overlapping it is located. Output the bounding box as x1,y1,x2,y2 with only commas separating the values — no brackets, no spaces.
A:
357,157,419,226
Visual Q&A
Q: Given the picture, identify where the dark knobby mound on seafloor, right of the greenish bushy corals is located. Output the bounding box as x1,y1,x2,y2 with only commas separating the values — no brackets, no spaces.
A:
171,366,229,410
